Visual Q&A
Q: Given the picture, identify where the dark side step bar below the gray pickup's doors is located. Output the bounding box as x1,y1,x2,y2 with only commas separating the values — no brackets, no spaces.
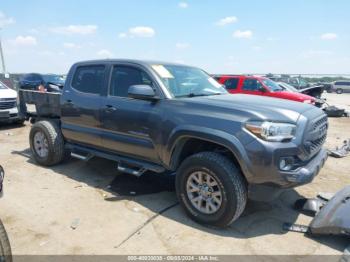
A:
66,143,165,176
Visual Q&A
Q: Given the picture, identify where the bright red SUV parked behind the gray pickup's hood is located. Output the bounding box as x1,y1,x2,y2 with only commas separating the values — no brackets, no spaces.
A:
215,75,316,105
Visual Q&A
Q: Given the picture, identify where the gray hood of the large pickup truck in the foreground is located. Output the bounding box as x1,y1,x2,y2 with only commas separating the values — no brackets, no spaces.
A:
178,94,315,123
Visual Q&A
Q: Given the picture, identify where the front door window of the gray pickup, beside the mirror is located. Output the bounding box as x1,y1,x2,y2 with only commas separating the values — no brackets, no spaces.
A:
109,66,152,97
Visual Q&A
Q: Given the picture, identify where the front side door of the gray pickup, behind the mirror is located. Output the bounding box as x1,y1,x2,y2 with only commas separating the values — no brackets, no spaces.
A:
101,64,161,162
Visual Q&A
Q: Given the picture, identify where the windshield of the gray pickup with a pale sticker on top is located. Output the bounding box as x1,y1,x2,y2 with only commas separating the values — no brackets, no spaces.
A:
152,65,227,97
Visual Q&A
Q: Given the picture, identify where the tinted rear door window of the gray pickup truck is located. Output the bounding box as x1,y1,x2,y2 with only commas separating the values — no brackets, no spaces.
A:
72,66,105,94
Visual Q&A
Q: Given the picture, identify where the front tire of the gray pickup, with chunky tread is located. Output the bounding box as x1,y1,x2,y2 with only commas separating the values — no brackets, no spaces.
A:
176,152,247,227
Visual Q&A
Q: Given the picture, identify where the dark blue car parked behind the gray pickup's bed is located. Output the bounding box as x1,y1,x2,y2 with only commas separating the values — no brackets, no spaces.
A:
19,73,64,92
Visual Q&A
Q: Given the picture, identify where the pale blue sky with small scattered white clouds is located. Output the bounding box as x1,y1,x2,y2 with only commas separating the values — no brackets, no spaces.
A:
0,0,350,74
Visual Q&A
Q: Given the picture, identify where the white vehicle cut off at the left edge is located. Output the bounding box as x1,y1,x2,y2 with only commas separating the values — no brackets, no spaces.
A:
0,82,24,124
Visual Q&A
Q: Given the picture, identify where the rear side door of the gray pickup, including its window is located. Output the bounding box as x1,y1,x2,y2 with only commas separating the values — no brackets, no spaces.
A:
61,64,107,147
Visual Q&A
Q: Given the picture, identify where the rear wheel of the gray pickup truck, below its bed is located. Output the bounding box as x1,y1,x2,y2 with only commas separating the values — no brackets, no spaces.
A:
29,120,65,166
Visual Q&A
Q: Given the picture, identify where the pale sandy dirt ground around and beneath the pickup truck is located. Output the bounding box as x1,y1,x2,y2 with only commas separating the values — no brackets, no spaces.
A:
0,94,350,255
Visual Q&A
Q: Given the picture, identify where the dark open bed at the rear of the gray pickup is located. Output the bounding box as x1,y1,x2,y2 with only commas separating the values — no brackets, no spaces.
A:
18,90,61,118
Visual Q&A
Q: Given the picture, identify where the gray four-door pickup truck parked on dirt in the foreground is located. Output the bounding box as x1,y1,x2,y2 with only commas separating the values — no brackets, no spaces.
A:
20,60,328,227
